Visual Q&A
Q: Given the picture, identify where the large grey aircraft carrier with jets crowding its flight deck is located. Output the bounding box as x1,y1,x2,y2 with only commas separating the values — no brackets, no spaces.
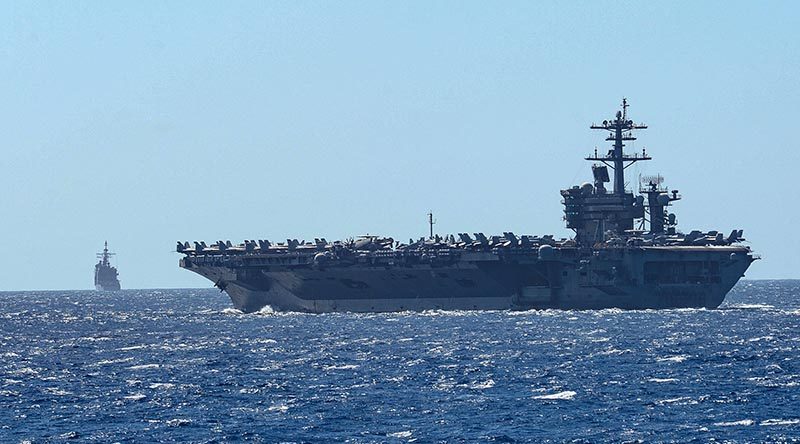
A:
177,100,758,313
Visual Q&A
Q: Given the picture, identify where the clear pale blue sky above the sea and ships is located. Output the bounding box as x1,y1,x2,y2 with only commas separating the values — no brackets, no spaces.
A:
0,1,800,290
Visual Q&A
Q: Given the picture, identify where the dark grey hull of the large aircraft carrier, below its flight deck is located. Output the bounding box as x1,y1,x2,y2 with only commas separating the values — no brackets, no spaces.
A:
182,247,752,313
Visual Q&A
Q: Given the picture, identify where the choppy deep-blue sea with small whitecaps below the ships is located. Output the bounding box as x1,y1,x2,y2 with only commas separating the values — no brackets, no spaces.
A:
0,281,800,443
